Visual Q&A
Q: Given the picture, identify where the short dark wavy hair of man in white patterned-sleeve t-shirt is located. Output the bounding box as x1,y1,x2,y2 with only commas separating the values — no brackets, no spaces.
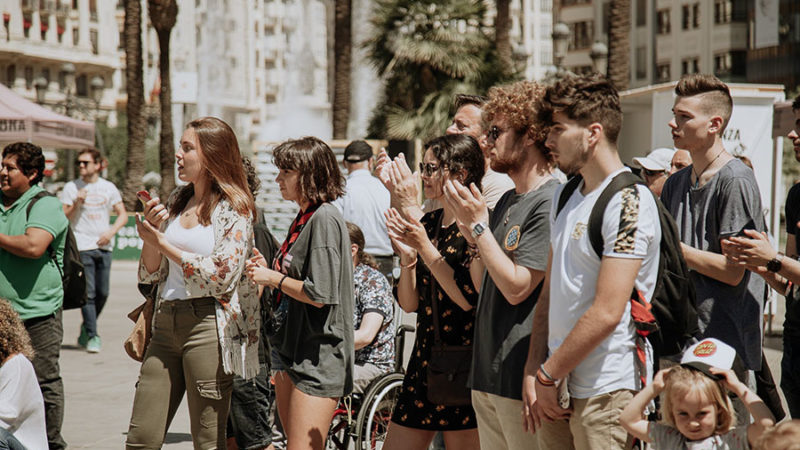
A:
539,74,622,144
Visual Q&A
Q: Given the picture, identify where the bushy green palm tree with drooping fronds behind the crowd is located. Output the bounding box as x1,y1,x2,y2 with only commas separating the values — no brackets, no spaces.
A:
367,0,502,139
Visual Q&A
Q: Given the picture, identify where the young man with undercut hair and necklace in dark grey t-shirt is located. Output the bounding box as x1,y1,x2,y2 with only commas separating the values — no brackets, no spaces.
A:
661,74,766,390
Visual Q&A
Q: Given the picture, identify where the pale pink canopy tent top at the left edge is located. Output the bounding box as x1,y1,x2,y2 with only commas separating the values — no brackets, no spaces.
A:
0,84,94,149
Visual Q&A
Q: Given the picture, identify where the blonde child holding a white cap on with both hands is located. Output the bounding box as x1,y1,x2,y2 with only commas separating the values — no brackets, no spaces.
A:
620,339,774,450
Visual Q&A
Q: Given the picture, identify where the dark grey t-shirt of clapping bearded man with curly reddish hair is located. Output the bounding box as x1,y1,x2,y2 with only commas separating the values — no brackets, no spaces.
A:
469,180,559,400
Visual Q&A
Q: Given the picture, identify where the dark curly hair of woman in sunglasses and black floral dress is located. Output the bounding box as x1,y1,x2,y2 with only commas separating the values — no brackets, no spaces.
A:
425,134,486,189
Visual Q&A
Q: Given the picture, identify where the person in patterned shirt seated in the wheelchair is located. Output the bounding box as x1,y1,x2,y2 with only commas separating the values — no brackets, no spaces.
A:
347,222,395,394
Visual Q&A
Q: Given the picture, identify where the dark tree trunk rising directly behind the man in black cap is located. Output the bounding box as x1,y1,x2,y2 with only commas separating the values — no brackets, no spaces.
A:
333,0,353,139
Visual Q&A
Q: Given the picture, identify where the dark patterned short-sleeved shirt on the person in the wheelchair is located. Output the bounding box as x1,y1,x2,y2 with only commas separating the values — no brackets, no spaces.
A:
353,264,394,372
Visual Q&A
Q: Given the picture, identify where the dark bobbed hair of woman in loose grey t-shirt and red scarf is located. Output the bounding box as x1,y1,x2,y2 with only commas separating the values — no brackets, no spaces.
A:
272,136,345,204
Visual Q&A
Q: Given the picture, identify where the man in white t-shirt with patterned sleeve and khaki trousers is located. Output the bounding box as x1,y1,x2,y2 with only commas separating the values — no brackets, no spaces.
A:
523,75,661,449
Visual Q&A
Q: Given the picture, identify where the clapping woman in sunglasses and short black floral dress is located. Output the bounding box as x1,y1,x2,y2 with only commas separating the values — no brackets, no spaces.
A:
383,135,485,450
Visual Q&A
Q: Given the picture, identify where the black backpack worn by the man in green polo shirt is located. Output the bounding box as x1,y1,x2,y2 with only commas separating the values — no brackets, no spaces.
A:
25,191,87,309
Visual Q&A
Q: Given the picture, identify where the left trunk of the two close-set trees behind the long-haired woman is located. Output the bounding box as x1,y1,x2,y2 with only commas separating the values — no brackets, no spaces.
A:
122,0,147,211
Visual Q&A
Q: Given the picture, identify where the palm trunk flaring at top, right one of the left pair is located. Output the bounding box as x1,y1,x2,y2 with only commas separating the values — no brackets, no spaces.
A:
147,0,178,199
